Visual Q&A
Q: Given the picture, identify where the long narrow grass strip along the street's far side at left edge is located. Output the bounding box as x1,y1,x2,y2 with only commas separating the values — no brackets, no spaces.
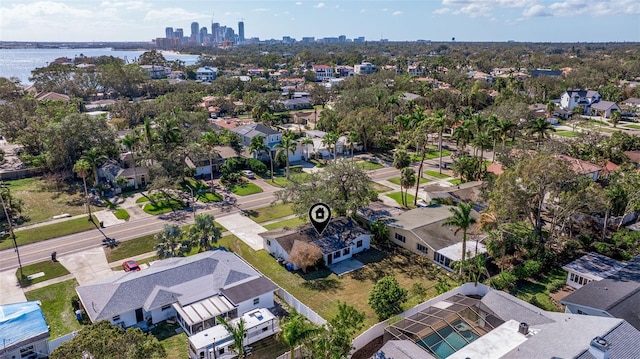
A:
0,216,98,250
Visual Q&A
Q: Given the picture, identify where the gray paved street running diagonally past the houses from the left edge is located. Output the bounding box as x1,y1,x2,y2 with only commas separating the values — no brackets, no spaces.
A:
0,159,450,271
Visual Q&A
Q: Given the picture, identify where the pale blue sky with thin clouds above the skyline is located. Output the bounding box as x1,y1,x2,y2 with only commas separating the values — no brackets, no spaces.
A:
0,0,640,42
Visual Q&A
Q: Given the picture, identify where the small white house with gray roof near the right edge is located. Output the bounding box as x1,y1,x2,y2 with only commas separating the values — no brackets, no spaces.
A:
562,252,624,289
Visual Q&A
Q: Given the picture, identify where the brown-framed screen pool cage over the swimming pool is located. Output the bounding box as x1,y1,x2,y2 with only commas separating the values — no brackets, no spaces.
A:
384,294,504,359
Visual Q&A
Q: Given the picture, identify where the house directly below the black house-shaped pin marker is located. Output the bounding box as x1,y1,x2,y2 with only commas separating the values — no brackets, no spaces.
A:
260,217,372,269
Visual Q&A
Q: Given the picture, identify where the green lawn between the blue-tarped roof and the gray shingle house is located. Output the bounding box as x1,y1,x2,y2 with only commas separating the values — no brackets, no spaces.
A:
25,279,82,339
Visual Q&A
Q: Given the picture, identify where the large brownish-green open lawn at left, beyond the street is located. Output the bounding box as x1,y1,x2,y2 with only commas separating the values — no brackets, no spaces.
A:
4,177,95,224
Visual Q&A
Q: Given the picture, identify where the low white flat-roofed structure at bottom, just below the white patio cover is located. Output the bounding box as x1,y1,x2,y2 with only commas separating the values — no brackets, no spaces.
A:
189,308,280,359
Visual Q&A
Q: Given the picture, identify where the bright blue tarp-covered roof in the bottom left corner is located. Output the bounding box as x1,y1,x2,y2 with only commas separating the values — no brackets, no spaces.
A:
0,301,49,346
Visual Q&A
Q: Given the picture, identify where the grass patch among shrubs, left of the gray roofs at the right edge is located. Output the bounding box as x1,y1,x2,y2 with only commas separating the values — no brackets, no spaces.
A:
511,268,567,312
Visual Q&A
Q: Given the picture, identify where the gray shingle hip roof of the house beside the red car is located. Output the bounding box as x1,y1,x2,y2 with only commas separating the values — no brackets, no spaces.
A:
76,251,276,322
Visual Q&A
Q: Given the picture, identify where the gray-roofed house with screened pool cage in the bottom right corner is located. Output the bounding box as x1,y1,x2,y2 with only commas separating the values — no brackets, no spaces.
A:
353,283,640,359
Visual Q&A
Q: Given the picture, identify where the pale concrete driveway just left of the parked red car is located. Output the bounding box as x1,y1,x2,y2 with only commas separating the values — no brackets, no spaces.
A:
58,247,116,285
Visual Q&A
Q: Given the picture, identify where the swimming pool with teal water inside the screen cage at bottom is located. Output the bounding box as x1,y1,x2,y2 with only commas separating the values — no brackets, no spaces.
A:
416,321,480,359
